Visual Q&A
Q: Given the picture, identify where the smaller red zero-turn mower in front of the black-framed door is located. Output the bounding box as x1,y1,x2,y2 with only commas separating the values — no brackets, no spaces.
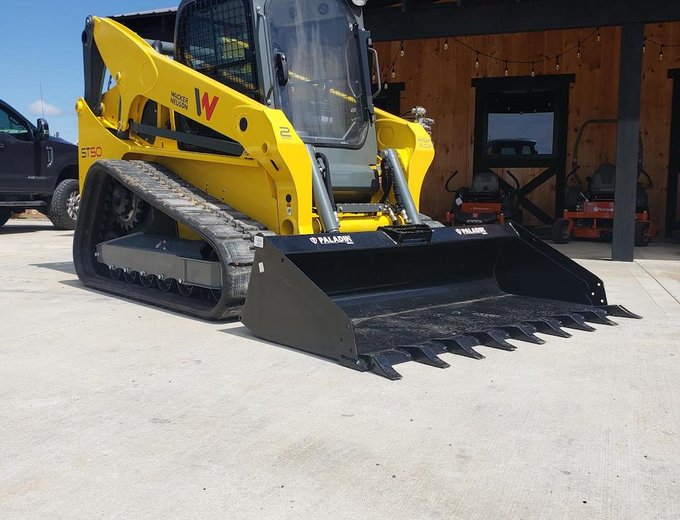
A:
445,170,522,226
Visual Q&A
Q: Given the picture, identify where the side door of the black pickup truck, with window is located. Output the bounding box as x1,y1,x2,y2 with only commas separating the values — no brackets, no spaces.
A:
0,104,44,193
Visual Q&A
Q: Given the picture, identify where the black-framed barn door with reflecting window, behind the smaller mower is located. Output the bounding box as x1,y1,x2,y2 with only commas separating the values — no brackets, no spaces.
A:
472,74,574,224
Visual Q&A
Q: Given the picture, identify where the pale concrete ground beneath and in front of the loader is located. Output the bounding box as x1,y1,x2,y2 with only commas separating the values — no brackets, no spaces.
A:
0,221,680,520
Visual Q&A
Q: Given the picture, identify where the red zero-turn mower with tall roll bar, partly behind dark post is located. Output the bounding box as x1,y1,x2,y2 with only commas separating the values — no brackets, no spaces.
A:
552,119,654,246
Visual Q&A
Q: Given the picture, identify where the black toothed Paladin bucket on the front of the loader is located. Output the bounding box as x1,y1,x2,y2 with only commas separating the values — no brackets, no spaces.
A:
241,223,639,379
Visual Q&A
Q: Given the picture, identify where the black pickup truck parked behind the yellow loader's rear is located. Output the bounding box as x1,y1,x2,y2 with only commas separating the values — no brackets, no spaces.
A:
0,100,80,229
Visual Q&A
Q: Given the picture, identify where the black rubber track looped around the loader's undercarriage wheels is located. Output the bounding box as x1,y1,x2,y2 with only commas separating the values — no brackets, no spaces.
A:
73,161,271,320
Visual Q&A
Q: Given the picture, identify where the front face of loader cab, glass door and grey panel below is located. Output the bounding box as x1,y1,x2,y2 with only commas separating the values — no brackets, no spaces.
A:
265,0,378,202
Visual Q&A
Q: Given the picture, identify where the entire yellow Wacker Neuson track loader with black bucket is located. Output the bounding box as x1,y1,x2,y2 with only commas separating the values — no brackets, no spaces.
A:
74,0,633,379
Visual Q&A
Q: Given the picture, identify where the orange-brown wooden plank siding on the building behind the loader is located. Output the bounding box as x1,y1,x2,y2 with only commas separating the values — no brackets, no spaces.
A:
376,23,680,232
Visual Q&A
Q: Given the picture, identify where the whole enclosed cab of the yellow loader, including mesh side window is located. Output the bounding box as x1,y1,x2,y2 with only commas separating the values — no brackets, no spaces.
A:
175,0,379,202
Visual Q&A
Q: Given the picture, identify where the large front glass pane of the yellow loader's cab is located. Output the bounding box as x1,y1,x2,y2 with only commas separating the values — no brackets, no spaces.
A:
267,0,368,147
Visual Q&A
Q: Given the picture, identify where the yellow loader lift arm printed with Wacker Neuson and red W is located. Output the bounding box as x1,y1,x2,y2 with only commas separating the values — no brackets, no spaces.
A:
77,17,313,233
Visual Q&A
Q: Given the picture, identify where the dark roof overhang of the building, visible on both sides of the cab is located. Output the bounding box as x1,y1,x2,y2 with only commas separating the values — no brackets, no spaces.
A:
115,0,680,41
